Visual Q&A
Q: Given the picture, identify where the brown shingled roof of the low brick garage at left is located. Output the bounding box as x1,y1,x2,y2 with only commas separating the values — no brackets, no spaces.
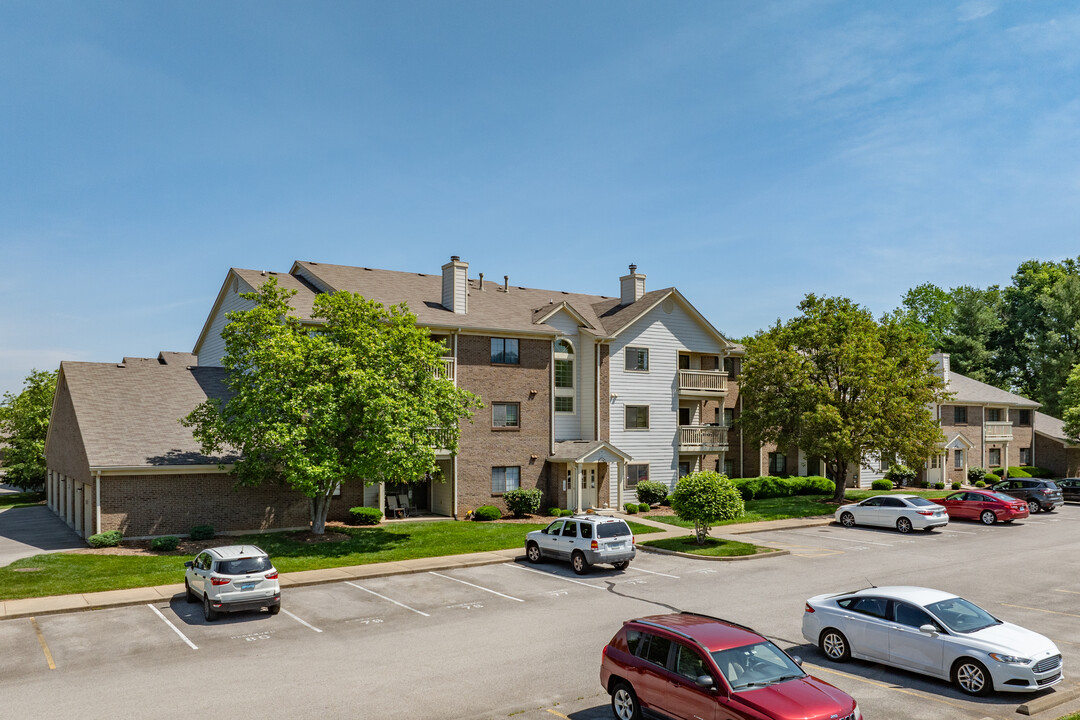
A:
51,353,237,472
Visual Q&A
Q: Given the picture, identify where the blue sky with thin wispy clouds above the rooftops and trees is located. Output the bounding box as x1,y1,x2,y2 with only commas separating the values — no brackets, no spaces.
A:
0,0,1080,392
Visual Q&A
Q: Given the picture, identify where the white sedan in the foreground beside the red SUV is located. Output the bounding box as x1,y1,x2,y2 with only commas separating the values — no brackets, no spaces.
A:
802,587,1063,695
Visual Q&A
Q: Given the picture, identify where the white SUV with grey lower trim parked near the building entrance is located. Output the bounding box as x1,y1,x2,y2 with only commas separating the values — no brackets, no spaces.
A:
525,515,634,575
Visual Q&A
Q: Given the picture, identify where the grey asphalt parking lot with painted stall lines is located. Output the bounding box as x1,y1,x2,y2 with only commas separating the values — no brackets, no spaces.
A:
0,505,1080,720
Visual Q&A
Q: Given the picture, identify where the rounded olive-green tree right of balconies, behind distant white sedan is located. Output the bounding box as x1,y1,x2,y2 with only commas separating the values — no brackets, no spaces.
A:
739,295,944,502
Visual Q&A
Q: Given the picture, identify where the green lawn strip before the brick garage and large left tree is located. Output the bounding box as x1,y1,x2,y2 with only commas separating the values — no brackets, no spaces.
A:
0,521,660,600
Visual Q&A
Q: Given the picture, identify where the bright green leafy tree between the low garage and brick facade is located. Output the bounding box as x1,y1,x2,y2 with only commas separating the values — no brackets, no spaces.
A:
180,279,480,533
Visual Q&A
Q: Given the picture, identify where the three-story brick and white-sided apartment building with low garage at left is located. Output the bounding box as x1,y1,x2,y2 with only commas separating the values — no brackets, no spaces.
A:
46,256,747,535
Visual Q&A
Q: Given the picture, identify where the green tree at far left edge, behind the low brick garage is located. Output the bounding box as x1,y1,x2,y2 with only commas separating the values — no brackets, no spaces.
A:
0,370,56,490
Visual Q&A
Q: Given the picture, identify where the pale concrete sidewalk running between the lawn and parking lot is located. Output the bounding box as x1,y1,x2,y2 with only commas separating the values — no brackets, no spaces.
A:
0,513,832,620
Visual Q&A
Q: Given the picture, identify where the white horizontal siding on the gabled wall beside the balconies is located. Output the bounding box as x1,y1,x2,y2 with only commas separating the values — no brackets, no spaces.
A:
602,302,723,506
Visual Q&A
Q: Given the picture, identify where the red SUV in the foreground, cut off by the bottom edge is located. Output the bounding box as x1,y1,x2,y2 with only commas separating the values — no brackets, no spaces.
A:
600,612,863,720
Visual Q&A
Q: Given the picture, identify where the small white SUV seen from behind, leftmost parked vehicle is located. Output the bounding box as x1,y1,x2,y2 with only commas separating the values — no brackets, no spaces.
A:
184,545,281,622
